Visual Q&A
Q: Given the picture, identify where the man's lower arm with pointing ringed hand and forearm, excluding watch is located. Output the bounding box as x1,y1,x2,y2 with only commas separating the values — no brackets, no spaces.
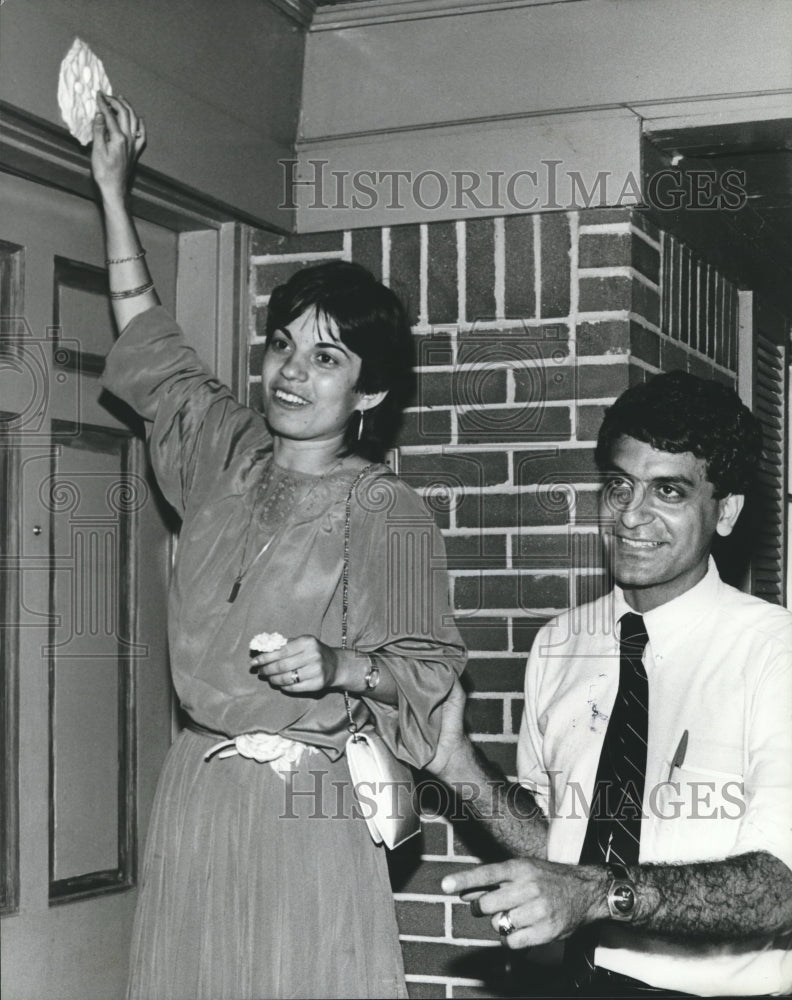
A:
443,851,792,948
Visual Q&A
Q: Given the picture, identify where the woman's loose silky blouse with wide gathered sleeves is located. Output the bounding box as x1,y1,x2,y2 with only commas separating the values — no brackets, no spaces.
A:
103,307,465,767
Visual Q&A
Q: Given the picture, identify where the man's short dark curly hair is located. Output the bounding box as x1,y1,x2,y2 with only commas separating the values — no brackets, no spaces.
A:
594,371,762,499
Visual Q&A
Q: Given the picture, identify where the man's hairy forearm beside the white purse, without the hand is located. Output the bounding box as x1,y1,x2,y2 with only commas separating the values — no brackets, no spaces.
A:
439,739,547,858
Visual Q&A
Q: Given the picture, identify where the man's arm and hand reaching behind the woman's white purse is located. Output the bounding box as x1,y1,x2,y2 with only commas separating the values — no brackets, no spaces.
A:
426,681,547,858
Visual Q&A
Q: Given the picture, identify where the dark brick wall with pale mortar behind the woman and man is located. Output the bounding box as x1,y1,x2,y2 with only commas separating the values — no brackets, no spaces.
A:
250,209,737,997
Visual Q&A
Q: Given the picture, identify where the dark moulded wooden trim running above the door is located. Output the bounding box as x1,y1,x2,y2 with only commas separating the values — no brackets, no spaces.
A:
0,101,290,232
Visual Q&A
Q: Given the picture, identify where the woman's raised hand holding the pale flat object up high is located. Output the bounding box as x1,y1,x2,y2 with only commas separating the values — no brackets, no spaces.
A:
91,92,146,201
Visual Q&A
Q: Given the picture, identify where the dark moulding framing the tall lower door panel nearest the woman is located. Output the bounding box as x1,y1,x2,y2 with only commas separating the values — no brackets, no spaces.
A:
48,420,136,906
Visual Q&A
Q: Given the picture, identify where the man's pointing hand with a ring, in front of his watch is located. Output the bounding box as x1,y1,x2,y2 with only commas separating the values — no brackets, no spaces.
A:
442,858,610,948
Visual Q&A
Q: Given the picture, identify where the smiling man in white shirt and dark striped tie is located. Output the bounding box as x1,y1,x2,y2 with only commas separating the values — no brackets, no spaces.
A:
431,372,792,996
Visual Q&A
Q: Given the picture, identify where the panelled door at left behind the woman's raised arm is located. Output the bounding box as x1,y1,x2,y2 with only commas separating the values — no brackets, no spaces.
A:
0,175,177,1000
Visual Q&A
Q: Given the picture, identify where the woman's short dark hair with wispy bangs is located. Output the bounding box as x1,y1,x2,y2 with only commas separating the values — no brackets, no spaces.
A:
265,260,414,461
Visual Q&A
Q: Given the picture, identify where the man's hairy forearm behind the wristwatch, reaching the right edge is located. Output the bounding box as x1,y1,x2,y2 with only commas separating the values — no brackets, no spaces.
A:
630,851,792,942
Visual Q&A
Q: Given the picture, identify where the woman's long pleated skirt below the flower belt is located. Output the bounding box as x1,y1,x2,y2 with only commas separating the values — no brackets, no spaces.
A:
128,731,407,1000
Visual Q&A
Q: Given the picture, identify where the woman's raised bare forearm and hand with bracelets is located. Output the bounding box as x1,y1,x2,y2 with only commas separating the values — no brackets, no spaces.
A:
91,93,159,331
